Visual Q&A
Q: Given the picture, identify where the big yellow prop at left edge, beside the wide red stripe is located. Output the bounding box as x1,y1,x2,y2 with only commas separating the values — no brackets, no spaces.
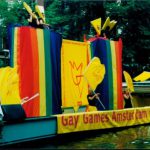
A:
0,67,21,105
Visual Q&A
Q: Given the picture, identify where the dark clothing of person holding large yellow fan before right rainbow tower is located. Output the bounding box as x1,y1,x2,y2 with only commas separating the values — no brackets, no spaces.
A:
87,94,101,110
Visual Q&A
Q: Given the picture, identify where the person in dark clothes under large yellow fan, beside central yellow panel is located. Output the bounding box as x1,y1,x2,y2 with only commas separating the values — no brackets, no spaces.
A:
87,90,101,110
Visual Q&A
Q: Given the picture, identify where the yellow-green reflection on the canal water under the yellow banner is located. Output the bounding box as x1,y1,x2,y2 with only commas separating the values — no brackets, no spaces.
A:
48,126,150,149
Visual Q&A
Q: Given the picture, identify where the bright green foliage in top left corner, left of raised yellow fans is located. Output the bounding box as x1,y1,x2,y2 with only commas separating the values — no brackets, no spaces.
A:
0,0,31,48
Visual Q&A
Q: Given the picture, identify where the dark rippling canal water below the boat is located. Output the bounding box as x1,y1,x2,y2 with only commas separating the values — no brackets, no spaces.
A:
10,125,150,149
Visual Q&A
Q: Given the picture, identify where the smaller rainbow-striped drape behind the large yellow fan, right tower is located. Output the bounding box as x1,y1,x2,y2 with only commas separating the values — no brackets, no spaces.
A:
90,38,123,110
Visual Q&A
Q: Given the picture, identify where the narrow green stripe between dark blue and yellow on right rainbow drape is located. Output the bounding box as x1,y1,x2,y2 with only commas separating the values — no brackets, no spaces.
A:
106,40,114,110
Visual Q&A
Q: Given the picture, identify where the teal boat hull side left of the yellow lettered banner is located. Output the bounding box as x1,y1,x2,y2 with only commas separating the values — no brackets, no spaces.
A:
0,117,57,146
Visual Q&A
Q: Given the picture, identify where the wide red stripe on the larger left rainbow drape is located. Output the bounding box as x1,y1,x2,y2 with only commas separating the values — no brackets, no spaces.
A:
18,27,34,117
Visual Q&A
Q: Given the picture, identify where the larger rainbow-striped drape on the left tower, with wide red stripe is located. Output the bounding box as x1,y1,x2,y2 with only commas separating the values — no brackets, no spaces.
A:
10,26,62,117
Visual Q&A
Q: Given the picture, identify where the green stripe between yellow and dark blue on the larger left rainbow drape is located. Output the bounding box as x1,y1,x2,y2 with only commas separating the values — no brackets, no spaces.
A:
44,30,52,115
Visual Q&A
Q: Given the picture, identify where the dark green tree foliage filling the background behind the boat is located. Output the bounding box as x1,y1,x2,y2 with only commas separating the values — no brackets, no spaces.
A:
0,0,150,76
